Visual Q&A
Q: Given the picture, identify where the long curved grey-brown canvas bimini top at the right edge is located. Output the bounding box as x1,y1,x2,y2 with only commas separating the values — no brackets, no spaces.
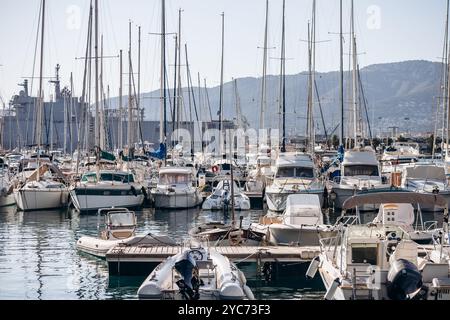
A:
342,191,448,210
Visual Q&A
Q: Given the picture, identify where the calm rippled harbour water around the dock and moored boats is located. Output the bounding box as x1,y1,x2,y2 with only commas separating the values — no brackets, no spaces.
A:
0,207,440,300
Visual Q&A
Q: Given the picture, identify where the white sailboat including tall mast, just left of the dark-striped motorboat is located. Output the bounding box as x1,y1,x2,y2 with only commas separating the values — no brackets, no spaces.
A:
14,0,69,211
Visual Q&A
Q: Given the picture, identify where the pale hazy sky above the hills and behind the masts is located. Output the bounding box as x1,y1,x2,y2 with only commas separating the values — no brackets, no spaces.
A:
0,0,446,101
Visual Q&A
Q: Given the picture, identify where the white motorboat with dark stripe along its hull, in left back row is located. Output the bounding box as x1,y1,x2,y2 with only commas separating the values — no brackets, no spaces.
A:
70,170,145,211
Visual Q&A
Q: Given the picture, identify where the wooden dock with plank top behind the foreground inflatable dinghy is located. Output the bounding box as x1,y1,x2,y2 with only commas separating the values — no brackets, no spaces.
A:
106,246,320,276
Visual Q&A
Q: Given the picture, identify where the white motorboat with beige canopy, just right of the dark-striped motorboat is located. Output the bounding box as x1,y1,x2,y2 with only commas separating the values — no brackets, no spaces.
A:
151,167,203,209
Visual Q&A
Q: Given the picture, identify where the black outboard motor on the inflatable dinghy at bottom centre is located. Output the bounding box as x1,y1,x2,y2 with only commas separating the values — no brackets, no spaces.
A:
175,251,200,300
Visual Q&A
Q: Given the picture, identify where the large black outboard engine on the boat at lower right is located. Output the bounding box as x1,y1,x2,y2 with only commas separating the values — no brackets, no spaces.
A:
387,259,422,300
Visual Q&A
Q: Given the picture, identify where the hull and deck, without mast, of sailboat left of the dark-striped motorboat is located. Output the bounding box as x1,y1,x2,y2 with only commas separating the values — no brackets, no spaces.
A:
14,164,69,211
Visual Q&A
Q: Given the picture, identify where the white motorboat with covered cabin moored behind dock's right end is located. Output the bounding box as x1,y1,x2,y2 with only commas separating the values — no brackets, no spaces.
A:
266,194,332,246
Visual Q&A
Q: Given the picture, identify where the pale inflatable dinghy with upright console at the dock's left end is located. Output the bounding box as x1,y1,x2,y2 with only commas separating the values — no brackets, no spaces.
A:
76,208,177,258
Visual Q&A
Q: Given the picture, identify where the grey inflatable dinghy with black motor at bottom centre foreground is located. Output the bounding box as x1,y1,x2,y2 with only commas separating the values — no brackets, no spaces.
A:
138,244,254,300
